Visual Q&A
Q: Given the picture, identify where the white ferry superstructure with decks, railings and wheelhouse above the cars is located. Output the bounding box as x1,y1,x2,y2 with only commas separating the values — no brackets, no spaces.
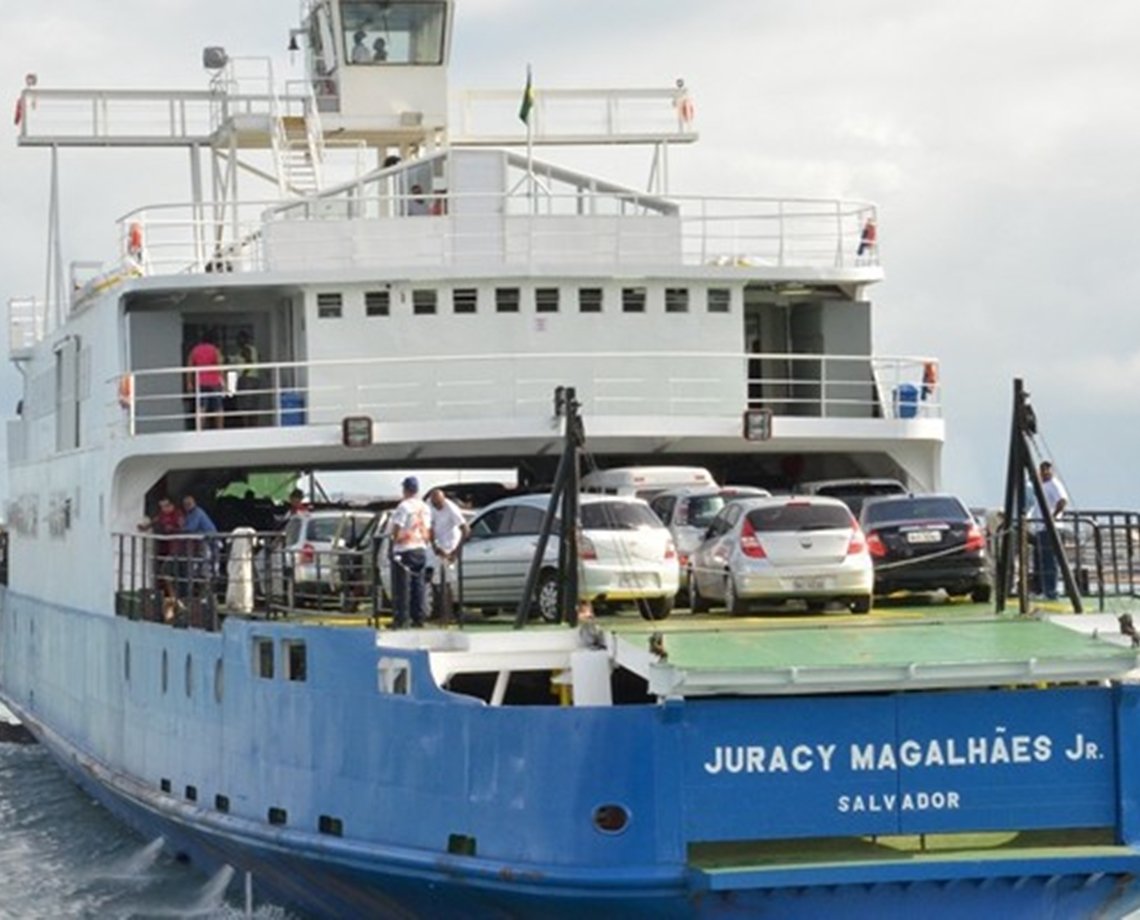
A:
8,0,943,609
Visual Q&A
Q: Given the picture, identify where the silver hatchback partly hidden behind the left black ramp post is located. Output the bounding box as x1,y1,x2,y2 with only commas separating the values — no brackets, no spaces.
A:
458,495,679,621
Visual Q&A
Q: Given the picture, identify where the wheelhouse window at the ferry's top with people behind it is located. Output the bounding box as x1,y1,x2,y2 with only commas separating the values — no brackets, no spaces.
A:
341,0,446,66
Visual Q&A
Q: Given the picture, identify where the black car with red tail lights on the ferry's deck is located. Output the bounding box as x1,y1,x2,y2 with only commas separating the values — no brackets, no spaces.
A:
860,495,993,603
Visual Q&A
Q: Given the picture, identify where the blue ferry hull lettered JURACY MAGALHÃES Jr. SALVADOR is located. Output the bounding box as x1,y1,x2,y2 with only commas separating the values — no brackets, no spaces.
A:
0,594,1140,918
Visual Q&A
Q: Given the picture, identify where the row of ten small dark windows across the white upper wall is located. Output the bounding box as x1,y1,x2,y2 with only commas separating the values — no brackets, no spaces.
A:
317,286,732,319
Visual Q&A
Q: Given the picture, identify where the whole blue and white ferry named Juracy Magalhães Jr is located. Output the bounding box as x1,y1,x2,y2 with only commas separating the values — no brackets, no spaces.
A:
0,0,1140,918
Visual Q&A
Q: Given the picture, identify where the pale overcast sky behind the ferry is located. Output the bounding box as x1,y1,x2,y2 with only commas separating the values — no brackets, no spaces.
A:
0,0,1140,508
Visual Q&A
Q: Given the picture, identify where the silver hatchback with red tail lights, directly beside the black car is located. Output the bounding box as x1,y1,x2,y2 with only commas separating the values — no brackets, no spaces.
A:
690,496,874,613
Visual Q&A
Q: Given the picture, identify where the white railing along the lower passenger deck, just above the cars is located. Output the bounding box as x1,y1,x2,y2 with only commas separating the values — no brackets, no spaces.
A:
107,352,942,434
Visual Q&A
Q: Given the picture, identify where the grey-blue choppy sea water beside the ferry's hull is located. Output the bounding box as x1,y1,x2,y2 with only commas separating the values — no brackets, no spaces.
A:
0,744,298,920
